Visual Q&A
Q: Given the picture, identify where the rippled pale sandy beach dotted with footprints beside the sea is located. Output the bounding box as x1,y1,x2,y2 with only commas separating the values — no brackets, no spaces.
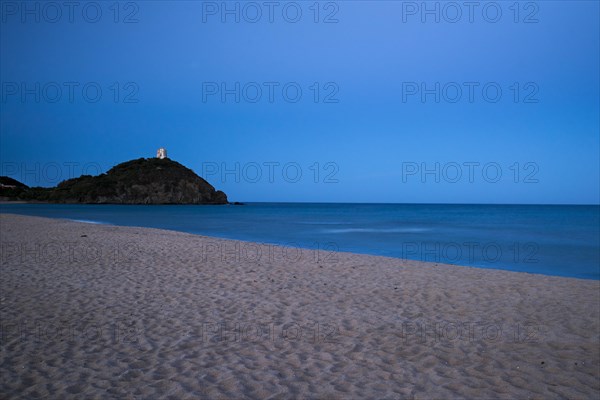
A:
0,214,600,399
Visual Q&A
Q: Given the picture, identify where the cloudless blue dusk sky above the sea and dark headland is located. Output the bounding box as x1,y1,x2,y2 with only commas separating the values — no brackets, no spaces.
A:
0,1,600,204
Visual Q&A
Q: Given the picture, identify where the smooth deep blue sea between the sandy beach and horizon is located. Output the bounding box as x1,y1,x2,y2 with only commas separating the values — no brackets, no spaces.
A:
0,203,600,279
